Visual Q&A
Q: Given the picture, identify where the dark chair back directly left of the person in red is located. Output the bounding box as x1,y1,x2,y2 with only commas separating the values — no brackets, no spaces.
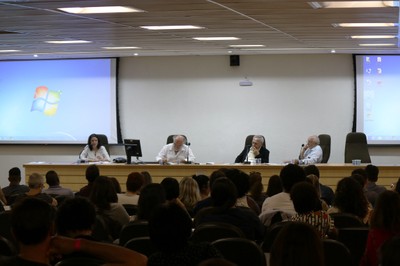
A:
338,226,369,265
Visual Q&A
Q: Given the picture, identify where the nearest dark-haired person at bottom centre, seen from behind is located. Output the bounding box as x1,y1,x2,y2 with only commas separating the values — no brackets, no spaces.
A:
148,203,221,266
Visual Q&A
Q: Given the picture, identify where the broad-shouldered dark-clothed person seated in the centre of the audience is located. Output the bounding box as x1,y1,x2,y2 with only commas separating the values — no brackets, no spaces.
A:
194,177,264,240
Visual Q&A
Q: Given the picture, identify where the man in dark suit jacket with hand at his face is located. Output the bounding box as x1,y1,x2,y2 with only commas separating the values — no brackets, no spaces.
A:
235,135,269,163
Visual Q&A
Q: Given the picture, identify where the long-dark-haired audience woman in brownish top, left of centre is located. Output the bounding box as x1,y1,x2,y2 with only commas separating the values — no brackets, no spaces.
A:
90,176,129,239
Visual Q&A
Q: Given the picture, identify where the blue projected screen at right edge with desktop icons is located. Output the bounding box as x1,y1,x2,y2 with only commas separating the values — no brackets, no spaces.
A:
355,55,400,145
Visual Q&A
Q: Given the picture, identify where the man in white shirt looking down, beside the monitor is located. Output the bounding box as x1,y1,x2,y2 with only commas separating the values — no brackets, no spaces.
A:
156,135,195,164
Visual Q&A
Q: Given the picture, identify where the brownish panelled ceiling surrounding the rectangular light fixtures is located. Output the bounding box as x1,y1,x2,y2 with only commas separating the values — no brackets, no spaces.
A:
0,0,400,60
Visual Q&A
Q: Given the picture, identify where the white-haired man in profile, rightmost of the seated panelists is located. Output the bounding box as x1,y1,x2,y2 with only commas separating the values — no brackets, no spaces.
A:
294,135,322,165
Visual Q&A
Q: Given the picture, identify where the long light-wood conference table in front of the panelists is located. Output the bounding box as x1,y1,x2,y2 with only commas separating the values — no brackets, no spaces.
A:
23,162,400,191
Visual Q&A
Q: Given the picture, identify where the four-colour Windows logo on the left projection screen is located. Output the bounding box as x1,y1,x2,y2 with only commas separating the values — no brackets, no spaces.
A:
31,86,61,116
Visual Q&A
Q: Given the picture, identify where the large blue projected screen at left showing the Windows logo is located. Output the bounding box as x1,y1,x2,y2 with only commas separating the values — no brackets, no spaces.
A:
0,59,117,144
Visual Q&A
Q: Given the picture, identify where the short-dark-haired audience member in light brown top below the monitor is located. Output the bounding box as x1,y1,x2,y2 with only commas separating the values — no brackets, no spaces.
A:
118,172,144,205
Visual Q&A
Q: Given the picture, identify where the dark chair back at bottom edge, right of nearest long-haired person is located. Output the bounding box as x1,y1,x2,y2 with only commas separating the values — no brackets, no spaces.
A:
322,239,351,266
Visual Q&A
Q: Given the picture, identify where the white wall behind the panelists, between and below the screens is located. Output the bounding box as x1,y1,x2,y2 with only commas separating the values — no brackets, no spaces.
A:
0,54,399,186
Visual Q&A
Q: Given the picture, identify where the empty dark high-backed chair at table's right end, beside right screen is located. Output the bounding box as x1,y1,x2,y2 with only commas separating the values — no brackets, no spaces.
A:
344,132,371,163
